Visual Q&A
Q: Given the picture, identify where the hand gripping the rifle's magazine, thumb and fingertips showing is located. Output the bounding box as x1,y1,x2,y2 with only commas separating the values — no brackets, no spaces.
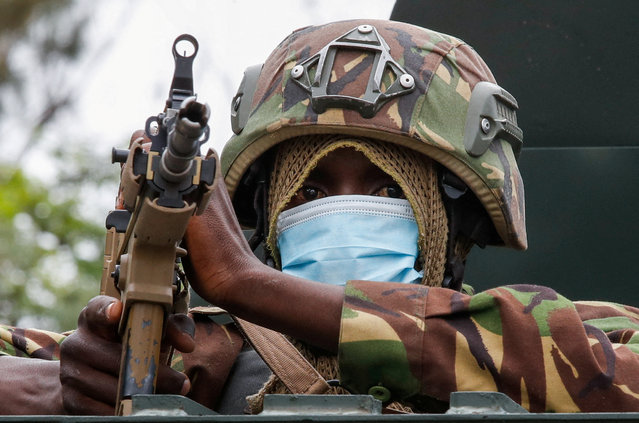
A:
60,296,195,415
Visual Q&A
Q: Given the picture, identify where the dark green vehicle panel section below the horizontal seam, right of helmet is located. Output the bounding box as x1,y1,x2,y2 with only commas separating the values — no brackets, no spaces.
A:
466,147,639,306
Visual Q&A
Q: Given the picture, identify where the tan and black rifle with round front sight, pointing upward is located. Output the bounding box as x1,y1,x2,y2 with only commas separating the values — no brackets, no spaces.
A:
100,34,216,415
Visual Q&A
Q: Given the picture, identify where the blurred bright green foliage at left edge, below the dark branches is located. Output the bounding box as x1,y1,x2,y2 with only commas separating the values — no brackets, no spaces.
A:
0,166,104,330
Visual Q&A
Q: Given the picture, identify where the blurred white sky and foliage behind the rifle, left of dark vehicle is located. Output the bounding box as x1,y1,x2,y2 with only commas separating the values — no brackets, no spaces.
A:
0,0,394,330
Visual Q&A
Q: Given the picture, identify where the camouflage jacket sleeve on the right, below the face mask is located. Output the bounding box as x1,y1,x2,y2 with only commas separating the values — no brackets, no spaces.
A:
339,281,639,412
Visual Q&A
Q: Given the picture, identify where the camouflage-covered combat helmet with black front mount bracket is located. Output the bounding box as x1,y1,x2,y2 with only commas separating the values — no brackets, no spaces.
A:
222,20,527,249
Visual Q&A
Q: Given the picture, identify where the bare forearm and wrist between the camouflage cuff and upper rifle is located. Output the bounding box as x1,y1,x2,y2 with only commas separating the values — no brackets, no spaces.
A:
185,181,344,351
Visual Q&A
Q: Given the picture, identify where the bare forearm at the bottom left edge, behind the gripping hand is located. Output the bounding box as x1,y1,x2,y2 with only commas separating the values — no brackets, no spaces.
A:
0,357,65,415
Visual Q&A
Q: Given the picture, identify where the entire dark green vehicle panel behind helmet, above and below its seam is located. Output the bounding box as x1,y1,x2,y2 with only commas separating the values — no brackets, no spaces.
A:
391,0,639,306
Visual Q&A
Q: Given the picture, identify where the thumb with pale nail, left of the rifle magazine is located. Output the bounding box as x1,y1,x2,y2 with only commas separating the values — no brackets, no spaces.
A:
78,295,122,342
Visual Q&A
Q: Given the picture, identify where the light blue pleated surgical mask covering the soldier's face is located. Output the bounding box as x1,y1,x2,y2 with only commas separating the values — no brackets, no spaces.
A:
277,195,422,285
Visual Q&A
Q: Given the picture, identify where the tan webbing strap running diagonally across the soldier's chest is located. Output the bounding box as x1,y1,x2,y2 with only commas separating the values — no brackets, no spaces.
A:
233,316,330,394
